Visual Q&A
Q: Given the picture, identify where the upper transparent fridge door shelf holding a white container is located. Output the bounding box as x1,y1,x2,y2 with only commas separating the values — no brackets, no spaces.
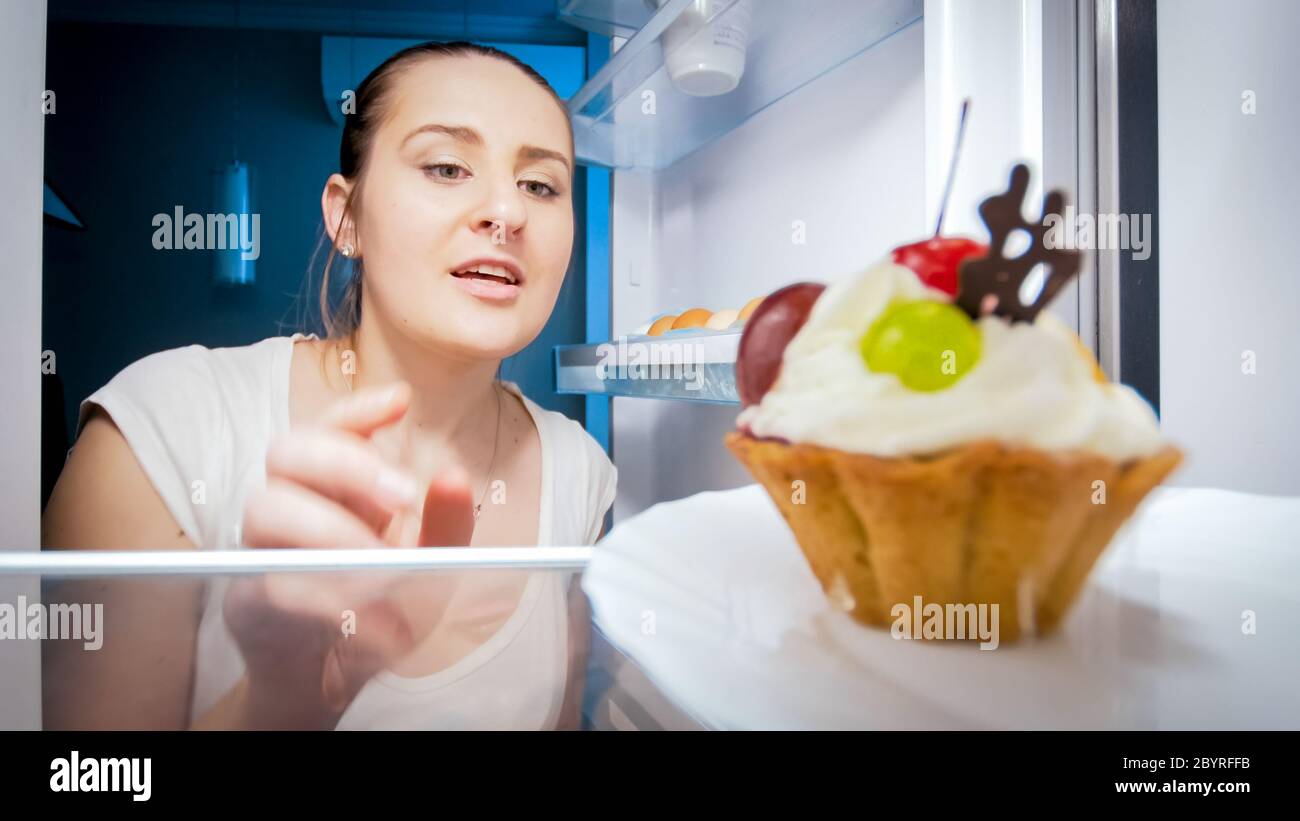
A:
560,0,922,169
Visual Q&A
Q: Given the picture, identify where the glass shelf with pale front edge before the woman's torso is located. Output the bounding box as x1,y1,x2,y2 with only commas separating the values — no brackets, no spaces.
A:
0,547,705,730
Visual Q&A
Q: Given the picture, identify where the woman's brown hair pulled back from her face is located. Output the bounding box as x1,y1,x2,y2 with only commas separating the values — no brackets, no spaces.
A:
306,40,573,348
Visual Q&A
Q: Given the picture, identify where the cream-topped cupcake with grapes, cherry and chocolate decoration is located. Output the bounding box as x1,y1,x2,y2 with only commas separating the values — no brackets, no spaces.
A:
727,166,1182,642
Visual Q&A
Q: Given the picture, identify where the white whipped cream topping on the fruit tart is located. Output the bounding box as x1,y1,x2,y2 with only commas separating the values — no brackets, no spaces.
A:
736,261,1165,461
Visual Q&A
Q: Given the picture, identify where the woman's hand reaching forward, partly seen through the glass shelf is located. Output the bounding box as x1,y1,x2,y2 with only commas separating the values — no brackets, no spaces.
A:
213,382,475,727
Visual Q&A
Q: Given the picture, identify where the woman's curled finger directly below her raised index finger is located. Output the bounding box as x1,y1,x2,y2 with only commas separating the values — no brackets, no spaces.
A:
267,427,421,534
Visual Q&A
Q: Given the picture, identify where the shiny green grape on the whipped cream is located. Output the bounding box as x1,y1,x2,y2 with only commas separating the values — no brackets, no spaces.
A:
861,300,980,391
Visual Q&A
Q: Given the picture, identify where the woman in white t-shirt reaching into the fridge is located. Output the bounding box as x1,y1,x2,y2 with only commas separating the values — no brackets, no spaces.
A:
42,43,616,727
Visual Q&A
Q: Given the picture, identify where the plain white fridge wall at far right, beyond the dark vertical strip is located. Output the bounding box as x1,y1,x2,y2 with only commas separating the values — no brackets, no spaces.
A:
1156,0,1300,494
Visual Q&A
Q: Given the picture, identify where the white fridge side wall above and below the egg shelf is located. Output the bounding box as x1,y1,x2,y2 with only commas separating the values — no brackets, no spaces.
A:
611,22,930,521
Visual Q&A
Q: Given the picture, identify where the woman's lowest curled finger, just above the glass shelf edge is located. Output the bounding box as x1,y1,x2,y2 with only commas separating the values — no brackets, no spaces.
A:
242,477,386,548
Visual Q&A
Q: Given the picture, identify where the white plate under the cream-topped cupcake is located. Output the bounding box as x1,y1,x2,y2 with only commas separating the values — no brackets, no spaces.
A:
584,485,1300,729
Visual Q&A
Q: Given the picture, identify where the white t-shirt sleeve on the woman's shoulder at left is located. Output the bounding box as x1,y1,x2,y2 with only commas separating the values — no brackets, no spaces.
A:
73,346,229,547
